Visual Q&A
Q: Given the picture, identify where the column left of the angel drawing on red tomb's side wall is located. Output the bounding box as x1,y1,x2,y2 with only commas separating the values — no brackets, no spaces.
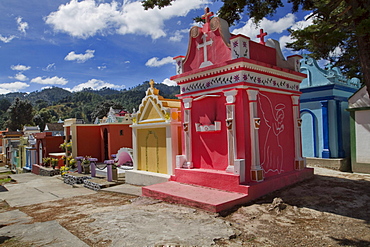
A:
247,89,264,182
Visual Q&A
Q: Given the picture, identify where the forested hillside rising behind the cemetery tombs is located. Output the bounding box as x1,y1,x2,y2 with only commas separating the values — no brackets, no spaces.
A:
0,81,179,129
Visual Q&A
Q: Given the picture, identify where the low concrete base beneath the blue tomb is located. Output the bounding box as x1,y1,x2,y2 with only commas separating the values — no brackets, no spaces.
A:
306,158,351,172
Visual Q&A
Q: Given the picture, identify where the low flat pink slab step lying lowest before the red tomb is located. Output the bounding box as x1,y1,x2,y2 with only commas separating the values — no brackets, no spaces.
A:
142,181,248,212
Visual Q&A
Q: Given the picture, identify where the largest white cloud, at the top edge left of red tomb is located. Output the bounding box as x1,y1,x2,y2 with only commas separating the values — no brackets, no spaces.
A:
45,0,209,39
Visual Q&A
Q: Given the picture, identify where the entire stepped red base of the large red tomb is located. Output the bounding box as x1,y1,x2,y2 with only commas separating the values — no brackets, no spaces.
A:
142,168,313,212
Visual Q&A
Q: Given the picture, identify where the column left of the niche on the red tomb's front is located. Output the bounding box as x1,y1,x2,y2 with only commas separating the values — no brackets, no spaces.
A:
183,98,193,169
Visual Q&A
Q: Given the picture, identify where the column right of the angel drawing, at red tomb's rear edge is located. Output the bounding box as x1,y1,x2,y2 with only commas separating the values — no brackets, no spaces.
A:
292,95,306,170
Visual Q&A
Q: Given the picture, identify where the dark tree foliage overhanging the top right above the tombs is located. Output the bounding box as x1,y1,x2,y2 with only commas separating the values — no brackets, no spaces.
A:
142,0,370,95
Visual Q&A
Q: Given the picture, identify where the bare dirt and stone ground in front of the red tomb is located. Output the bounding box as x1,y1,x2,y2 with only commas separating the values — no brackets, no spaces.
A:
0,168,370,247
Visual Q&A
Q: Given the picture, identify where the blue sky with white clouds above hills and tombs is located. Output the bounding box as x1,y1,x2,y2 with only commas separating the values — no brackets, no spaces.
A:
0,0,311,94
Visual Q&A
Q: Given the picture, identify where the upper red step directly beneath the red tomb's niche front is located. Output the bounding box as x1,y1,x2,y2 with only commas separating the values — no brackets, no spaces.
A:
170,168,249,194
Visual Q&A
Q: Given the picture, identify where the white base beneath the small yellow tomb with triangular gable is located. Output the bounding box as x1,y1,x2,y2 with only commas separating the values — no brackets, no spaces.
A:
125,170,170,186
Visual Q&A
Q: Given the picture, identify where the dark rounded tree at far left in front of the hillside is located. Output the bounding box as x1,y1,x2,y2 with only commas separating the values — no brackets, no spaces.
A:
6,98,33,131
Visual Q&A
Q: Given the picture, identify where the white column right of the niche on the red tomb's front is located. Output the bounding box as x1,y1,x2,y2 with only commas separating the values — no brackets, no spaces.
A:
224,90,238,173
